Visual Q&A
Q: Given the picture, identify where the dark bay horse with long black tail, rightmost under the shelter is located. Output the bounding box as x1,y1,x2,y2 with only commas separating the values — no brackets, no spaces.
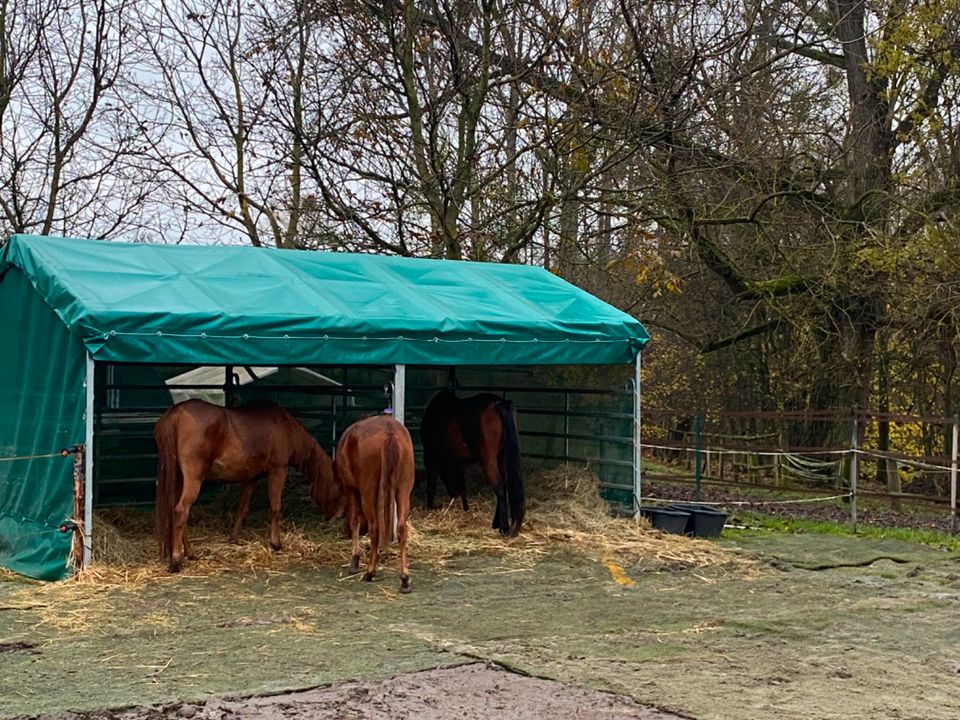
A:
420,390,524,535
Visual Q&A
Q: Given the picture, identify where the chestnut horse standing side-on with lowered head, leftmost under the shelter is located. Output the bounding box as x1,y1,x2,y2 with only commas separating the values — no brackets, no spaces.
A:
153,400,340,572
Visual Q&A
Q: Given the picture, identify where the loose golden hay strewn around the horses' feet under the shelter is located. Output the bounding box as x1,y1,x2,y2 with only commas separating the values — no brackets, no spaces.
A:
62,467,744,585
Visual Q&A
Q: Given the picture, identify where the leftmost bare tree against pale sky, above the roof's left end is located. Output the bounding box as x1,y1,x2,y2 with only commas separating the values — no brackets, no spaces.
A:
0,0,153,242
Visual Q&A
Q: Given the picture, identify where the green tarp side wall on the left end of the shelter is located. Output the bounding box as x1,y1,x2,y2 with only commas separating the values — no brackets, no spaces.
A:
0,269,85,580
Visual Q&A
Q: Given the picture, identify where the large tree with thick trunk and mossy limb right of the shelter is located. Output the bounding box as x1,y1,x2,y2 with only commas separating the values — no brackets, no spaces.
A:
584,2,958,428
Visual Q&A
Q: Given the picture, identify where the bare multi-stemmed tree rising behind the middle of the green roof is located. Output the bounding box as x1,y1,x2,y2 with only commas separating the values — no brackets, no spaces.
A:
288,0,565,260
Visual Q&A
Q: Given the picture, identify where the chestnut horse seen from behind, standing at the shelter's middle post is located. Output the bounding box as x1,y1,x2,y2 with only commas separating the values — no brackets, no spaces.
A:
333,415,414,593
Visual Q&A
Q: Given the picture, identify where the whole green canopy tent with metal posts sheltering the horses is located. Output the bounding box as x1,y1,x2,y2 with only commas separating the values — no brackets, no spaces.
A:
0,235,649,579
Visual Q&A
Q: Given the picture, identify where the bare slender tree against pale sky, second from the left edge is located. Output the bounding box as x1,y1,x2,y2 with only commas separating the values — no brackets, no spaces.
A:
132,0,309,247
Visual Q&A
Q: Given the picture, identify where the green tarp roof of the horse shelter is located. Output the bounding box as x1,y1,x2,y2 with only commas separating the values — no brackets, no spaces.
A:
0,235,649,365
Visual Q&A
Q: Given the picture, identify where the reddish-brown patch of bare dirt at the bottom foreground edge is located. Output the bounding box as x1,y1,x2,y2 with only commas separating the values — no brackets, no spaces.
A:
36,663,681,720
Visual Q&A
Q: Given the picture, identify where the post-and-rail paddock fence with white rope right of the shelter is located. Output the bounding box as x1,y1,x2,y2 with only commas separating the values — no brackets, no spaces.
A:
641,408,958,531
